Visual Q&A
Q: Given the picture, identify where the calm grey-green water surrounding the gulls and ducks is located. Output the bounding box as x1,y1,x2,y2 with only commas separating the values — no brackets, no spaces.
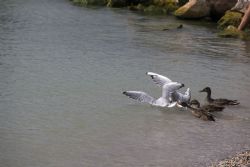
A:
0,0,250,167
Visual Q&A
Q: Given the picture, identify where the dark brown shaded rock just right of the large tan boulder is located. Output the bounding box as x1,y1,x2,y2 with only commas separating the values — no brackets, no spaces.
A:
206,0,237,20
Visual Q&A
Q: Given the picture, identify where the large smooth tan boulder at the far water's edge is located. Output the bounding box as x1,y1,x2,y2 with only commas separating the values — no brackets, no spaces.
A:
174,0,210,19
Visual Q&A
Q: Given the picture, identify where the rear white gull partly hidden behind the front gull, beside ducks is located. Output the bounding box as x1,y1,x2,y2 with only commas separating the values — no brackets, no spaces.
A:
146,72,191,107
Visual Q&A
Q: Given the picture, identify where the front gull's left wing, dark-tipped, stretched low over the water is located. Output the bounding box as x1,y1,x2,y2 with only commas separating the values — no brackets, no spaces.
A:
123,91,155,104
